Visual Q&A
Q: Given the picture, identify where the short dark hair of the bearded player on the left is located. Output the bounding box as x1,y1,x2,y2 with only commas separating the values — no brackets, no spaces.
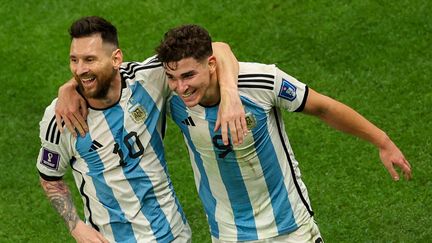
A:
69,16,119,48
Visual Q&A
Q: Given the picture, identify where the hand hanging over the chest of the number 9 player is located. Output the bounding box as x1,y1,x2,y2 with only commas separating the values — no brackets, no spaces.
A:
214,86,248,145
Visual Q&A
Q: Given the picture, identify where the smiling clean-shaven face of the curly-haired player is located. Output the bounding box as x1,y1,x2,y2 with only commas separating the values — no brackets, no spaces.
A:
164,56,220,107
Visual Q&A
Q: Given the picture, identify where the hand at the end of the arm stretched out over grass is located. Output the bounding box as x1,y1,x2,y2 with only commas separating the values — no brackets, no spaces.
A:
379,138,412,181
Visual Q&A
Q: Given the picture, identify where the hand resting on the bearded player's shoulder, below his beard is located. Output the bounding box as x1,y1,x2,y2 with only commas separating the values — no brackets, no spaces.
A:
55,79,88,137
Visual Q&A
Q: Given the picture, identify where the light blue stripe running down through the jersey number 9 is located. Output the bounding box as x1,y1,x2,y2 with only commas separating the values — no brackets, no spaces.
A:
206,107,258,241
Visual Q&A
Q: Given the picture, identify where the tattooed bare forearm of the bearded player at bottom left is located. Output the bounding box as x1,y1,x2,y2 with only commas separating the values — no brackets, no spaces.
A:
39,178,108,242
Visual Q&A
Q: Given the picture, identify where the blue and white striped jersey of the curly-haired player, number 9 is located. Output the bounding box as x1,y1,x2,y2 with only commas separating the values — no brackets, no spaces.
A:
169,63,313,241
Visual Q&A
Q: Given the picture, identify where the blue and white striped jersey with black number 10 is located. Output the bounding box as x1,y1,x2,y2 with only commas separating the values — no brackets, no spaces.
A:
37,59,188,242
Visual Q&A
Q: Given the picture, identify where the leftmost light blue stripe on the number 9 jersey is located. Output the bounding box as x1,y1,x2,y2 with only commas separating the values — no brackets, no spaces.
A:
169,96,219,238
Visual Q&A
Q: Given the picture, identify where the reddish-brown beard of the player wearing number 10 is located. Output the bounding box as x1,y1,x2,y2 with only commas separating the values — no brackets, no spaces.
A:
75,69,117,99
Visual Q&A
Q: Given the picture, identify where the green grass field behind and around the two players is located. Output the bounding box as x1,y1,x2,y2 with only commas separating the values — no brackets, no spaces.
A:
0,0,432,243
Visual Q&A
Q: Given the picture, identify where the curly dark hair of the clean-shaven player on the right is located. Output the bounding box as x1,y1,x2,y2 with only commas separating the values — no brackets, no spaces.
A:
156,24,213,68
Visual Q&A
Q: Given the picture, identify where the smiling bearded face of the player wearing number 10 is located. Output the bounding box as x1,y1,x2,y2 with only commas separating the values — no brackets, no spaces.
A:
69,34,121,99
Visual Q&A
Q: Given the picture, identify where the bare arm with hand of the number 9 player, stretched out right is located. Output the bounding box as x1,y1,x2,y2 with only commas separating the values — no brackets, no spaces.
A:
303,88,412,180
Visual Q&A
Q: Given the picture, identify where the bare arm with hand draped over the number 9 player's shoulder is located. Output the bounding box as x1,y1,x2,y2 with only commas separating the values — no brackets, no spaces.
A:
212,42,247,145
